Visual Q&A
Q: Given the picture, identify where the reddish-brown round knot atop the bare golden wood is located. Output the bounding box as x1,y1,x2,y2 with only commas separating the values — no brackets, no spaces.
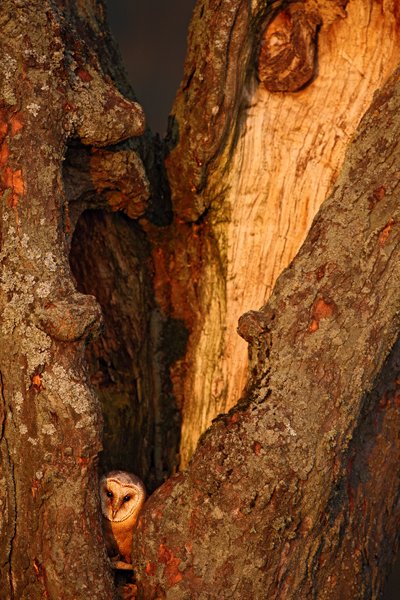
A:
258,4,321,92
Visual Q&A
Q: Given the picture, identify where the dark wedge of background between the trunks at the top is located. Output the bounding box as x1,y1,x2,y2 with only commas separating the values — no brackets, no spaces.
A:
106,0,195,134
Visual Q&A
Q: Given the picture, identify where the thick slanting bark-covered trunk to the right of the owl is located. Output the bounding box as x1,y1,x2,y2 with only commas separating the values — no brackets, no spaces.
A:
134,63,400,600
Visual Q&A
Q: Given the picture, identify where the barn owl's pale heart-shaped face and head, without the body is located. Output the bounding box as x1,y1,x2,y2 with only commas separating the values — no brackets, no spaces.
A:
100,471,146,523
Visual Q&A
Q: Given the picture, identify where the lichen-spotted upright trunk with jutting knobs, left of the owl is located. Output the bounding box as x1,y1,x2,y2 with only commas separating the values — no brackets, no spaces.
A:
0,0,148,600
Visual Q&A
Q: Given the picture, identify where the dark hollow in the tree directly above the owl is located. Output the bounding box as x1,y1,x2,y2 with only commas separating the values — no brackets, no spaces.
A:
70,210,180,492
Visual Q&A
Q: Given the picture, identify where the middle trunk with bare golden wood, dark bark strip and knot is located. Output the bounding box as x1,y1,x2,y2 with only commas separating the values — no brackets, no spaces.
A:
153,0,400,466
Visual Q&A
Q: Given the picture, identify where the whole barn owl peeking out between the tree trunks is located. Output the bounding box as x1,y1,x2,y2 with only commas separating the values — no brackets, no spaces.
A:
100,471,146,564
